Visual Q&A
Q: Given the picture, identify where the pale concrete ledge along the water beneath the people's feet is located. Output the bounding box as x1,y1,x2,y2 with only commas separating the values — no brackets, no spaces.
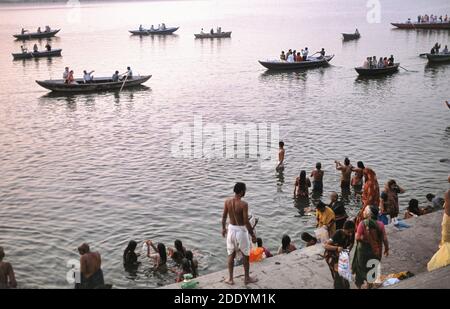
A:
163,211,442,289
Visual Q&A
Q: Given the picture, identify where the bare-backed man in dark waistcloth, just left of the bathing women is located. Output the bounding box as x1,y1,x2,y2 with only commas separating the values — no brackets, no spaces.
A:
77,243,105,289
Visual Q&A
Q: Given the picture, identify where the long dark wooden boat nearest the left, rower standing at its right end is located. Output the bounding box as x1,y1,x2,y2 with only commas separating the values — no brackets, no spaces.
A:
36,75,152,93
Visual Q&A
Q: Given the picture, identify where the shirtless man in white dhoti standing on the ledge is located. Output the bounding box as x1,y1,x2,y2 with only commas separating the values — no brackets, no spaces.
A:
222,182,258,285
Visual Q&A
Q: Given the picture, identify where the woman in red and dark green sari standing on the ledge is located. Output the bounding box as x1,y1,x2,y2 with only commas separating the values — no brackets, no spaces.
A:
352,206,389,288
